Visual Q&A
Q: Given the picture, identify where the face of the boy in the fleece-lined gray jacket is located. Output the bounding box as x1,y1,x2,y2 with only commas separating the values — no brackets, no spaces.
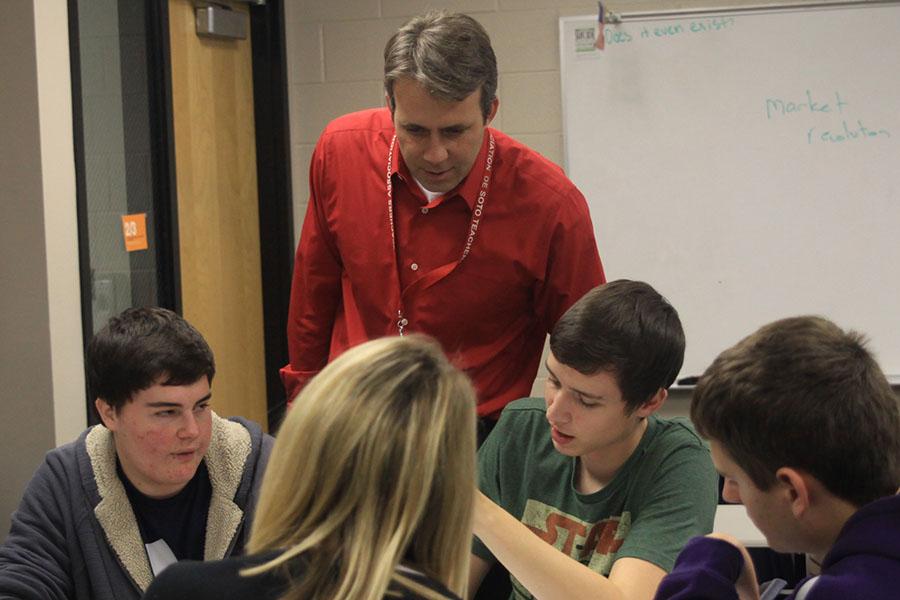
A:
97,376,212,498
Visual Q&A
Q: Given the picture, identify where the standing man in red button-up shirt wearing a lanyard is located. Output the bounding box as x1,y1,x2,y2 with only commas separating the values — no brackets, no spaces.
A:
281,12,604,432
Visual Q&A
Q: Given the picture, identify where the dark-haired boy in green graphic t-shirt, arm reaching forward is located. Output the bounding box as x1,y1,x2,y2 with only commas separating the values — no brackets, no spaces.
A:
469,280,717,600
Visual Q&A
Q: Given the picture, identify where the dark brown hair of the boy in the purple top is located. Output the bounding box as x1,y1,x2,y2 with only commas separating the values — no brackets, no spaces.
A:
691,316,900,506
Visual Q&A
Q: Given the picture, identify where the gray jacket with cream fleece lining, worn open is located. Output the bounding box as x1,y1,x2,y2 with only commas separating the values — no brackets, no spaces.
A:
0,415,273,600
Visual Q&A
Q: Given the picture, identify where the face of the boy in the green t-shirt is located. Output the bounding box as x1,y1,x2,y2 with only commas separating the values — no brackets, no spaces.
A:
544,352,646,458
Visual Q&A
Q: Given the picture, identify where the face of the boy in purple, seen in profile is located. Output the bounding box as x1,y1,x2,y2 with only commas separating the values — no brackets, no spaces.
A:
709,440,805,552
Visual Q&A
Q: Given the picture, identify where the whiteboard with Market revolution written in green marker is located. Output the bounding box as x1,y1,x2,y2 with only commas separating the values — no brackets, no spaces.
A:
560,5,900,376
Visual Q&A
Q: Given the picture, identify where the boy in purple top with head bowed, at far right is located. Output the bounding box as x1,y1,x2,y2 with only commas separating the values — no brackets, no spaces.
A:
657,317,900,600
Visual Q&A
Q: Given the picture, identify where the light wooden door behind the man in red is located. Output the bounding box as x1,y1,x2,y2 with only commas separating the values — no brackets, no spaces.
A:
169,0,267,428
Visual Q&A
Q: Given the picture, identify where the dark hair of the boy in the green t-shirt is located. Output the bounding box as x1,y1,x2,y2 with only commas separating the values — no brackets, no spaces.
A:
550,279,684,413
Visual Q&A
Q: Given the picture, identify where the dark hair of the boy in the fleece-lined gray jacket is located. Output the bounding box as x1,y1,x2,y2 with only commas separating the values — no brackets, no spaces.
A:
87,308,216,412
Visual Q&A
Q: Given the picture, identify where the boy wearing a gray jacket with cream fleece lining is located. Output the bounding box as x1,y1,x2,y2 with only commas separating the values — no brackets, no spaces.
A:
0,308,272,600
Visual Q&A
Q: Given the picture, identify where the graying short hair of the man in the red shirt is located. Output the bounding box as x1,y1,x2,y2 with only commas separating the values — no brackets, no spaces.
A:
384,11,497,119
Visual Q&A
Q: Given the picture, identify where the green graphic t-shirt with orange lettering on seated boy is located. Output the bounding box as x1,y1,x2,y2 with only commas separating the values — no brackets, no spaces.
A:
473,398,718,600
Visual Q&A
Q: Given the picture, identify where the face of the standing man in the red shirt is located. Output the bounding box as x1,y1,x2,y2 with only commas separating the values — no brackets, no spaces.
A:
393,78,498,194
